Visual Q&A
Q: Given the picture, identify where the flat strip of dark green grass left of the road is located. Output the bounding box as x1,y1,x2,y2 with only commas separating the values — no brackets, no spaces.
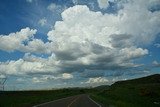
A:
0,89,83,107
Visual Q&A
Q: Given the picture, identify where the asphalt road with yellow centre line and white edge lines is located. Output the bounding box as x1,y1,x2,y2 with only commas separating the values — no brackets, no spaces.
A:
33,94,101,107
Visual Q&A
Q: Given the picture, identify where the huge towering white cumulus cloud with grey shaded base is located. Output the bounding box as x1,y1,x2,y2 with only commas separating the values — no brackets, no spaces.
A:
48,5,152,69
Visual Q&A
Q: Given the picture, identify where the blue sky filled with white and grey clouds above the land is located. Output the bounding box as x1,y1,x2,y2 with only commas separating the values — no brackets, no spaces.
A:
0,0,160,90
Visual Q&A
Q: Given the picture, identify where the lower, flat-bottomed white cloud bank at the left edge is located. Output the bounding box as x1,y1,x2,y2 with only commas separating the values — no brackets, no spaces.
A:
0,53,59,75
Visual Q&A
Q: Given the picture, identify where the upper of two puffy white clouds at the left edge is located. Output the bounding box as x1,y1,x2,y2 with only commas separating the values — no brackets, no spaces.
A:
0,27,52,54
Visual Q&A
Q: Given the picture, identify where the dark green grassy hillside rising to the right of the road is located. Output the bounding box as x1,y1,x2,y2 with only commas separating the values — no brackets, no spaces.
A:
92,74,160,107
